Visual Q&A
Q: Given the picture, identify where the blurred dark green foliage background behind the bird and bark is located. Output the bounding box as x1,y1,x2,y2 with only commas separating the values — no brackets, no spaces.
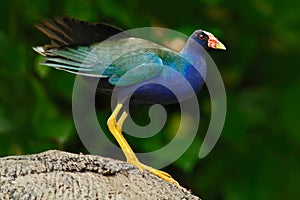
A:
0,0,300,200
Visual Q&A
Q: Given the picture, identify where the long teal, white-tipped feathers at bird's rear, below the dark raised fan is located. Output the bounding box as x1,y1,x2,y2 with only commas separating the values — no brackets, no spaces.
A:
33,46,106,77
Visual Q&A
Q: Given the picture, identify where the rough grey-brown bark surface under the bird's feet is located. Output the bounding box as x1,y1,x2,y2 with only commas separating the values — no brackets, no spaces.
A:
0,150,200,200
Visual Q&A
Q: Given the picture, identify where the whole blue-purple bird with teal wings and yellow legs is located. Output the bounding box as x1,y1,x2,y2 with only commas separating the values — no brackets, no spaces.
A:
33,17,226,185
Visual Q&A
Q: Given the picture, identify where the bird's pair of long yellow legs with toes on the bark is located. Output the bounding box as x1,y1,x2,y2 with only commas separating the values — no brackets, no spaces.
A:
107,104,179,186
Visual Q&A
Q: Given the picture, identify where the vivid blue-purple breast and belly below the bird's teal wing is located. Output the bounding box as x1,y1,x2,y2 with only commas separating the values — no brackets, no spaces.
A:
127,64,204,105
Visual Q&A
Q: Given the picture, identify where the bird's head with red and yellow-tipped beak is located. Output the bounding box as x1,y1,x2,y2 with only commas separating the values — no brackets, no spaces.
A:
191,30,226,50
